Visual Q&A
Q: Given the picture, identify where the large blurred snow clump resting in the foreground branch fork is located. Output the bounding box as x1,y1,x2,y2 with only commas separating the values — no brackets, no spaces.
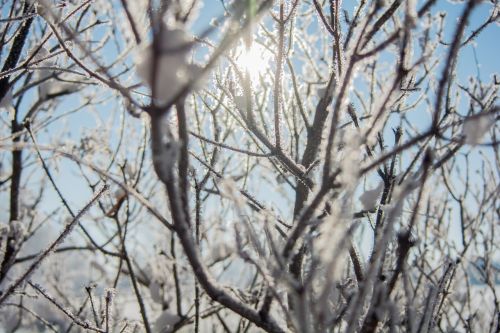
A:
136,26,203,104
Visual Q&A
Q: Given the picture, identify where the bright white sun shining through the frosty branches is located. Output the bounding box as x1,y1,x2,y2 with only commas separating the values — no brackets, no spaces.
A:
236,43,270,82
